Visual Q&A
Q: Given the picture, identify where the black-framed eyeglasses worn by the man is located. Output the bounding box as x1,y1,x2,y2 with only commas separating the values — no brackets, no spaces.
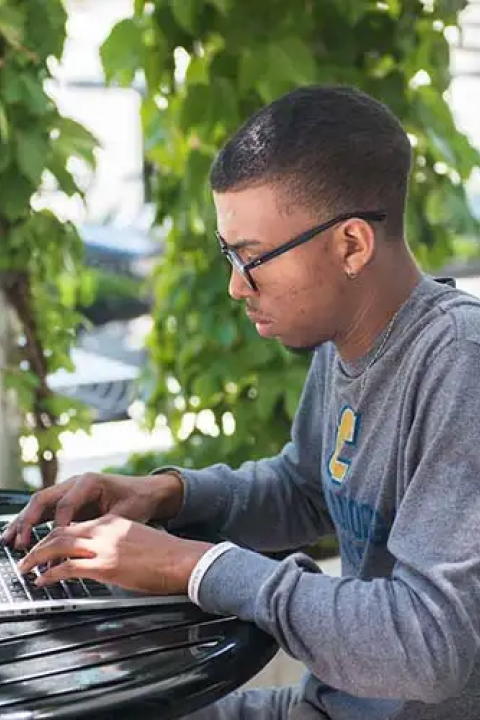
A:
215,210,387,291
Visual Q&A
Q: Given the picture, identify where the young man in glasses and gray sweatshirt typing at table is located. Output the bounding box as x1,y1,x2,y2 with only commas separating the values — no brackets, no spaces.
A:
6,87,480,720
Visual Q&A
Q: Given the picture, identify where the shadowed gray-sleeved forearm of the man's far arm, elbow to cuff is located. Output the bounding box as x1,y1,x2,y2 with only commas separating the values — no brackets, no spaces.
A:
161,450,332,551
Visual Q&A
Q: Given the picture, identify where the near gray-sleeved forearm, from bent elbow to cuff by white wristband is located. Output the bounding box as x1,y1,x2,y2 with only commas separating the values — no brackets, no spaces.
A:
194,548,472,704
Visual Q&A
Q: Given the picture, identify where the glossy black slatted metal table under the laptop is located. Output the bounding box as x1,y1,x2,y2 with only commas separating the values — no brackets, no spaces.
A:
0,491,277,720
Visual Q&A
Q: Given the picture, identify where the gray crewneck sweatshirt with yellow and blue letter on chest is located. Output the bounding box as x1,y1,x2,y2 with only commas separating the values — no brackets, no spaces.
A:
167,277,480,720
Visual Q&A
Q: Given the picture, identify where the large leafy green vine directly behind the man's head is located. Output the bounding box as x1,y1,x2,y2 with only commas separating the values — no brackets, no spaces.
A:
102,0,479,478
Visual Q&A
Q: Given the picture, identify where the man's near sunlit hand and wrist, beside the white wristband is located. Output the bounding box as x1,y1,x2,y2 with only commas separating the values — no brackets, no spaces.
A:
18,515,212,595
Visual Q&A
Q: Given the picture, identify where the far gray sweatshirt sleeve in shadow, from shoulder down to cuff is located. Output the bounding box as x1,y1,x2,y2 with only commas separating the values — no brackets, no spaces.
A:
161,351,333,551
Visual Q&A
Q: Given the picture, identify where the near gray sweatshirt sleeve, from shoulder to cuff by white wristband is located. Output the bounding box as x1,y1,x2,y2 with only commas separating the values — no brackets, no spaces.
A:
192,343,480,702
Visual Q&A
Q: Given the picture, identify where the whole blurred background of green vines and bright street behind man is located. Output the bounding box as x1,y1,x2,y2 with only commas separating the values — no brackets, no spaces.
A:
0,0,480,682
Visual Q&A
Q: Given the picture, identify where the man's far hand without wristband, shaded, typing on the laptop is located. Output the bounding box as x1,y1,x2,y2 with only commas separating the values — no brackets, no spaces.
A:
2,472,183,547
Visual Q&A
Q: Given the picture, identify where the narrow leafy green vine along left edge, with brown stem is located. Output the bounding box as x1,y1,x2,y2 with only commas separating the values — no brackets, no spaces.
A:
0,0,95,485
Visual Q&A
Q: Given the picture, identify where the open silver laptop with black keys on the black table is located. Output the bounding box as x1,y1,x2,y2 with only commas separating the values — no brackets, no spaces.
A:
0,513,190,620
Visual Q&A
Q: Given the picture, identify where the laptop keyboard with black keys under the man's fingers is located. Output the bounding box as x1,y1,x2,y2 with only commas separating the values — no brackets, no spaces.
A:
0,522,112,604
